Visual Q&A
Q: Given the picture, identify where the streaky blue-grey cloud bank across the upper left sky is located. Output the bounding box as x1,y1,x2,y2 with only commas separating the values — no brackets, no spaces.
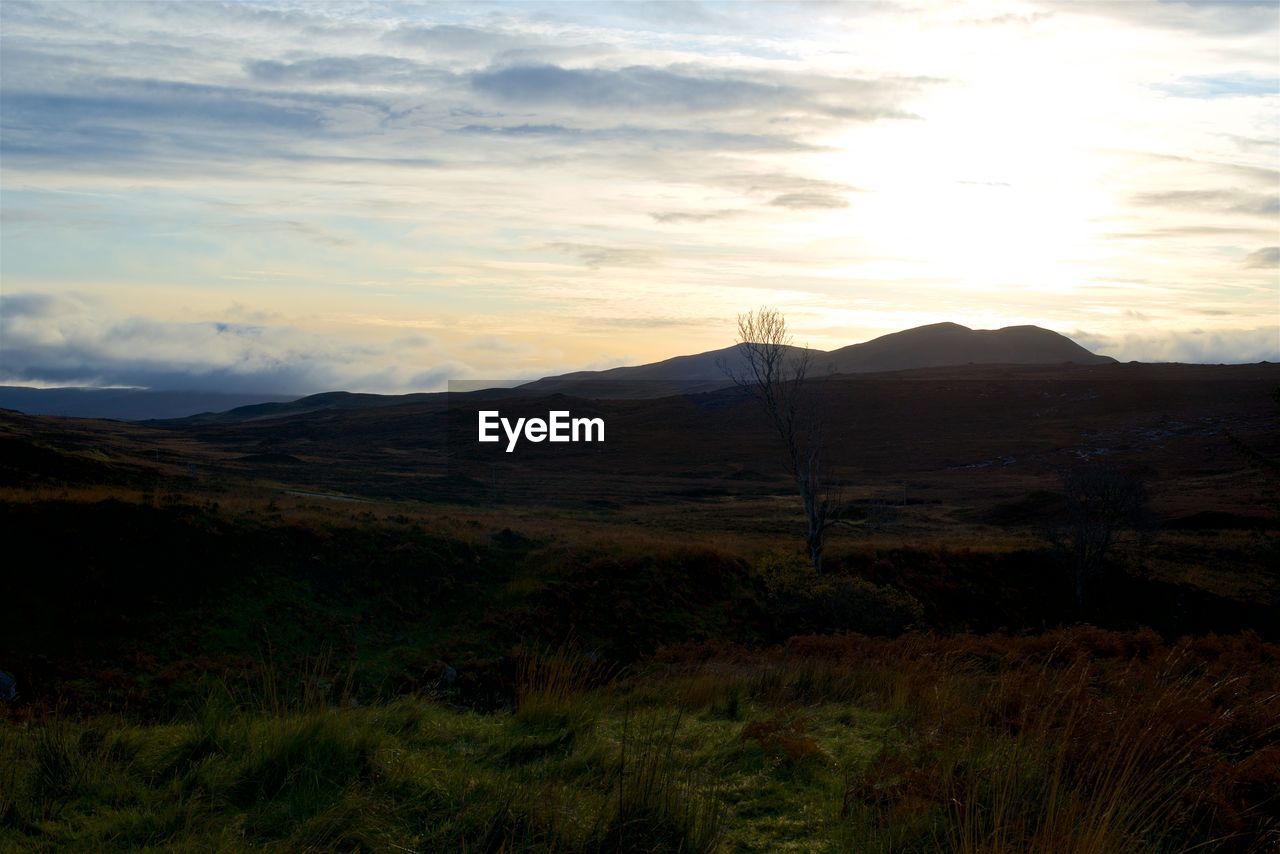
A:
0,4,932,195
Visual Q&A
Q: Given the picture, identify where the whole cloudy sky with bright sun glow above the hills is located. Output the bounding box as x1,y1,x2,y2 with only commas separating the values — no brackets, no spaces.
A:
0,0,1280,393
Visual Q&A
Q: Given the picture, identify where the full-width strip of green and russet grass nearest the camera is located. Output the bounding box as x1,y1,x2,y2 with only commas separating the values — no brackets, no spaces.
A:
0,630,1280,854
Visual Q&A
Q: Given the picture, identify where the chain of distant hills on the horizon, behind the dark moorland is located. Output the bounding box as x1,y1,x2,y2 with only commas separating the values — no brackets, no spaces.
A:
0,323,1115,424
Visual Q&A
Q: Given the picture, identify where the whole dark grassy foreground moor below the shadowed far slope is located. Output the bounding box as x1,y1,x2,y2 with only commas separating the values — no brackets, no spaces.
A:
0,376,1280,854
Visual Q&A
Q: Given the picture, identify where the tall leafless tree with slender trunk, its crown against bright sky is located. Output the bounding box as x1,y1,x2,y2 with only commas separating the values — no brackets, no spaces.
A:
721,306,854,572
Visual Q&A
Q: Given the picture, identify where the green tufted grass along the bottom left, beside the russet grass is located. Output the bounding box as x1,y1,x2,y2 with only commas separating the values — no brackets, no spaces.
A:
0,700,733,851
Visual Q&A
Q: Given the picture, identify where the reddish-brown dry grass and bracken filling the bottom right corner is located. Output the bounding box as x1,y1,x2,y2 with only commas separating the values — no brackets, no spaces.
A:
650,627,1280,854
